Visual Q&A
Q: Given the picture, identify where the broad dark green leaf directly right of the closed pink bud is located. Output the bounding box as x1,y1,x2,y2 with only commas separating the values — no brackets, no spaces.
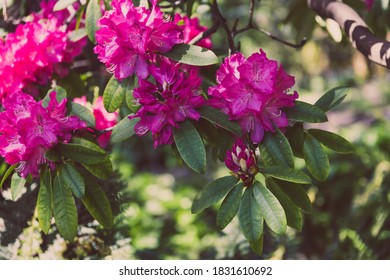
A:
260,128,294,168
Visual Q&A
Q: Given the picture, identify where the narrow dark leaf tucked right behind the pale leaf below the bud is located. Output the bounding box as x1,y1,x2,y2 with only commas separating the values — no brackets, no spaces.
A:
266,179,303,231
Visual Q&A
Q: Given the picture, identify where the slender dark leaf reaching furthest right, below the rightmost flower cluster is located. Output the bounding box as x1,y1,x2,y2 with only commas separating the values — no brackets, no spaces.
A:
308,129,354,154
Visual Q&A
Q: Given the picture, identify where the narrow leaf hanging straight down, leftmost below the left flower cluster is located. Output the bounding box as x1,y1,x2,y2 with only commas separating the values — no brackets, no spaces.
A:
37,168,53,234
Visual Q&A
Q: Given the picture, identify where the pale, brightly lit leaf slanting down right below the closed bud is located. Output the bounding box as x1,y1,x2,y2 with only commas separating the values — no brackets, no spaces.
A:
253,182,287,235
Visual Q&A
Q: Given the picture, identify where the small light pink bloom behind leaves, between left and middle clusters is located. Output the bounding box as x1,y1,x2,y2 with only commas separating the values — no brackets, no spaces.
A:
73,96,118,148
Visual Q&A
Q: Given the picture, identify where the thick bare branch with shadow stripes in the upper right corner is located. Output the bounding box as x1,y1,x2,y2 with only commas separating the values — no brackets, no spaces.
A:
307,0,390,68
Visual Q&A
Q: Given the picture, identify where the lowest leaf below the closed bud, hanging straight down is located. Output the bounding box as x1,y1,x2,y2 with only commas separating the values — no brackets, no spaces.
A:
238,187,264,242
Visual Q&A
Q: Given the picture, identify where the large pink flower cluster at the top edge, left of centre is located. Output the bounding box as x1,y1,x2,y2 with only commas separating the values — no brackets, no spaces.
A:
95,0,183,80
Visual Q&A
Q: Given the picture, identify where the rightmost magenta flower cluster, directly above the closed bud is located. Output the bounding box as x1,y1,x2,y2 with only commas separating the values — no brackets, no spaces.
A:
208,50,298,143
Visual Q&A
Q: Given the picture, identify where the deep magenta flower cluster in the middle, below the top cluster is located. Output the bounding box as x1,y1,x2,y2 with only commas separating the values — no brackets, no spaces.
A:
133,59,205,148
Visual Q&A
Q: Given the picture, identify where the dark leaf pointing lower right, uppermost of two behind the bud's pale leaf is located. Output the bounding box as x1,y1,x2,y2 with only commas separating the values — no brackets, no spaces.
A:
277,181,313,214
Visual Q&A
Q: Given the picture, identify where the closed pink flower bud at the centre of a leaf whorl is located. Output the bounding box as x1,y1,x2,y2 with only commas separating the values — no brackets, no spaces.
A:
225,139,258,186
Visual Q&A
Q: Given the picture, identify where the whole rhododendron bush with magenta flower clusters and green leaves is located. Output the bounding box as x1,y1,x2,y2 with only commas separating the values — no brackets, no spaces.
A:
0,0,386,254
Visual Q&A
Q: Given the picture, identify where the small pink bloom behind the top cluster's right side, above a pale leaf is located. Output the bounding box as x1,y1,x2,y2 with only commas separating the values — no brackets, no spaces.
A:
174,14,213,49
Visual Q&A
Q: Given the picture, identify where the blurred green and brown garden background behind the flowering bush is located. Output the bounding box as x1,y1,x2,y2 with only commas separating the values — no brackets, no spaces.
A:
0,0,390,259
